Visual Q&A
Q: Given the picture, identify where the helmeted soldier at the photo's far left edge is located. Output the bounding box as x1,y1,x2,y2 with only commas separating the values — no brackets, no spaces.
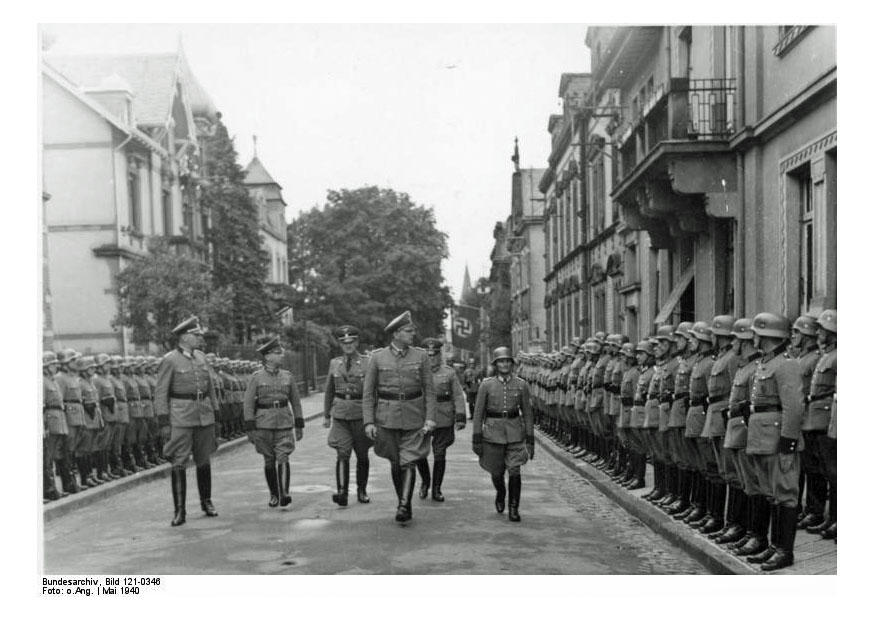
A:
43,351,69,501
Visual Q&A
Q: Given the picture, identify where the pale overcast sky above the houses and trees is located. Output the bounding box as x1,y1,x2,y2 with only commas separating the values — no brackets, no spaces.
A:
43,24,589,297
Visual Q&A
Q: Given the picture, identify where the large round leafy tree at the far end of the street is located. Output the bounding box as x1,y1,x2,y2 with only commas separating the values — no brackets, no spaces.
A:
288,186,452,346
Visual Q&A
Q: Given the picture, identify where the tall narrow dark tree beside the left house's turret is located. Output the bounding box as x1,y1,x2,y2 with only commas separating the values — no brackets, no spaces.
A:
200,116,275,344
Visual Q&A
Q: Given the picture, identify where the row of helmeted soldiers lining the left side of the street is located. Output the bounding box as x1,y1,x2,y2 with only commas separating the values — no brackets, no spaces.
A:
43,349,261,501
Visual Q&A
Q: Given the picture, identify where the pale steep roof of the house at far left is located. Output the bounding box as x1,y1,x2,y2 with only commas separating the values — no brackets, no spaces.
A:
45,51,216,126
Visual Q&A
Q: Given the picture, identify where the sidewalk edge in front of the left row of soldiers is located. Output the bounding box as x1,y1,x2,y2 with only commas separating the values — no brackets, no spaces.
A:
43,392,324,523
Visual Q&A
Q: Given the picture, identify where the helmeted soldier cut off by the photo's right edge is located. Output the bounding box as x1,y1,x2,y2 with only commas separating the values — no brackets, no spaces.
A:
802,310,838,540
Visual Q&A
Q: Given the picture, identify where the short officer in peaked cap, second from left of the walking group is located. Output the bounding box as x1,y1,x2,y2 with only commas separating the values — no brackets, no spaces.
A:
243,338,304,508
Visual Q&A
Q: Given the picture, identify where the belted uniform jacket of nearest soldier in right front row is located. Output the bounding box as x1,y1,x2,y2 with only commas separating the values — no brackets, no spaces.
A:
747,351,814,454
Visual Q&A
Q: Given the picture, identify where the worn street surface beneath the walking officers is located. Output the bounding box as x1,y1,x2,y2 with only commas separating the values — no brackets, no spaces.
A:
44,395,707,575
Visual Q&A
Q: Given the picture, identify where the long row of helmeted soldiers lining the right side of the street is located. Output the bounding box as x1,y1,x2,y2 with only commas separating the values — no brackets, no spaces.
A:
519,310,838,571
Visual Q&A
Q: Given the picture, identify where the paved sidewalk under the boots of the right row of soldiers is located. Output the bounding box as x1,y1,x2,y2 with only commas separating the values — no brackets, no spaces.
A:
535,430,838,575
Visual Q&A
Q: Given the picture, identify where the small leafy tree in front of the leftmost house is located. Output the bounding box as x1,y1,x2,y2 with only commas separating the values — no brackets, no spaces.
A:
113,238,227,349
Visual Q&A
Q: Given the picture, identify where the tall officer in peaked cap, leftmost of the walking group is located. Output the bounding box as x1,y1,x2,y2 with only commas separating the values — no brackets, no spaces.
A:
155,316,219,526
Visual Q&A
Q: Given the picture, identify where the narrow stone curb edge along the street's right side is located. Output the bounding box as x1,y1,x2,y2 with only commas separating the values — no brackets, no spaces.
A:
535,430,760,575
